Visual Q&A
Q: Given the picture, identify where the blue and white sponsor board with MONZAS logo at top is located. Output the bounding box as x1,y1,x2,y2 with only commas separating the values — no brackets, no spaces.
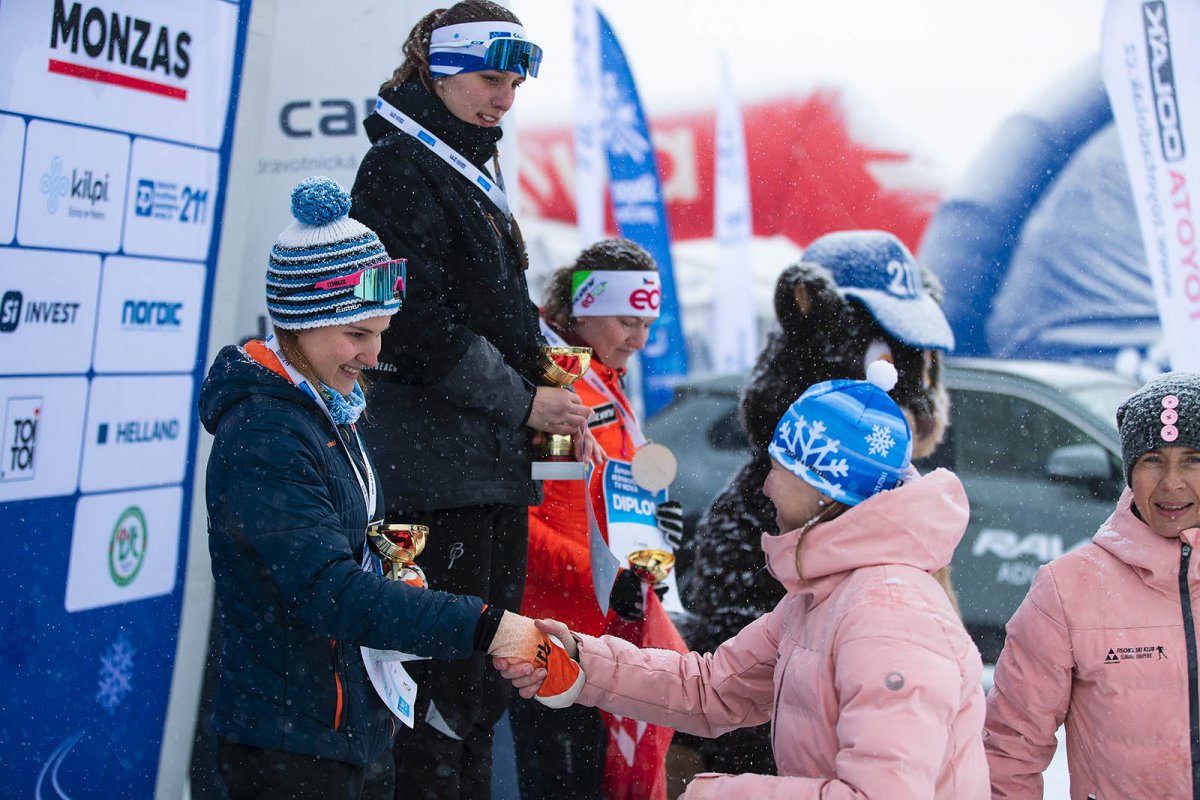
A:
0,0,250,800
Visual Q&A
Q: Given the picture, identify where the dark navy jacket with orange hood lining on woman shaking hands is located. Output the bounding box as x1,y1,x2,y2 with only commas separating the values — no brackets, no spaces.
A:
199,347,490,766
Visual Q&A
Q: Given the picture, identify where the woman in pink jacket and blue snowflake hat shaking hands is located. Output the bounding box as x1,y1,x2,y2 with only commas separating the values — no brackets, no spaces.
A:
496,362,988,800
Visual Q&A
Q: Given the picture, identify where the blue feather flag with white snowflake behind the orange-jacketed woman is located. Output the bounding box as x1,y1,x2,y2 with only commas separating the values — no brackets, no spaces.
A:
596,10,688,415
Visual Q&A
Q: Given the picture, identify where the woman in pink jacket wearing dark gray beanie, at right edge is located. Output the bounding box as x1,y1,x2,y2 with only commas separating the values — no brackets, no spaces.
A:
984,372,1200,800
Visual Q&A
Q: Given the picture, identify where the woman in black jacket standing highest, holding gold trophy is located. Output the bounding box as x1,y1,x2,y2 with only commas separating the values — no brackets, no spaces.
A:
350,0,590,800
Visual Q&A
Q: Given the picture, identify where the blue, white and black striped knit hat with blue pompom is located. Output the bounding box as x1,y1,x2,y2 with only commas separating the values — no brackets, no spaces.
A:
266,178,400,330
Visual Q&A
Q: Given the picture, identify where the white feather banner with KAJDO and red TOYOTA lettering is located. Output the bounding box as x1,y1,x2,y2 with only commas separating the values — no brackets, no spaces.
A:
1102,0,1200,371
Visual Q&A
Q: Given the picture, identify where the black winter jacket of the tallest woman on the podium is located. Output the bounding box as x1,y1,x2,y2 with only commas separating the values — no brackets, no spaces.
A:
350,80,545,512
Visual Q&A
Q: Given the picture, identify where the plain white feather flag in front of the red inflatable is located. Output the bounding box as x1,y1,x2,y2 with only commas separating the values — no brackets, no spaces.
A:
710,53,758,372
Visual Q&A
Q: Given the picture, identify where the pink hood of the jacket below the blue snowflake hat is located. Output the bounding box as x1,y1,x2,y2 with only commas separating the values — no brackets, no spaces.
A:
762,469,971,602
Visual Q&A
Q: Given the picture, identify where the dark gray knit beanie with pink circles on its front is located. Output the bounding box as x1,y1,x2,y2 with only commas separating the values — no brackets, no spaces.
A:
1117,372,1200,486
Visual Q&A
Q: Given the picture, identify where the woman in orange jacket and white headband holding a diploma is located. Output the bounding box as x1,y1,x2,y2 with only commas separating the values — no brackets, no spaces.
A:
509,239,683,800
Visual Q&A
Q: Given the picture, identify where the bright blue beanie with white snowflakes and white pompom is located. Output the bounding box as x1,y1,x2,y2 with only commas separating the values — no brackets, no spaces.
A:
767,361,912,506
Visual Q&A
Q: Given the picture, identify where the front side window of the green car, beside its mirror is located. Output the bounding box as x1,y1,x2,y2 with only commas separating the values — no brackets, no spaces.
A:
948,390,1093,477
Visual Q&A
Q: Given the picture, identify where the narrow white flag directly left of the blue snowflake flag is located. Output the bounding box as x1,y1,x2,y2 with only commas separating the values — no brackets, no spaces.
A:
575,0,608,247
